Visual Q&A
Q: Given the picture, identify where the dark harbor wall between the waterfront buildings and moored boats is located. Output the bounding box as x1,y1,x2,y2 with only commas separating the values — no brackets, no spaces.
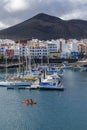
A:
0,59,78,68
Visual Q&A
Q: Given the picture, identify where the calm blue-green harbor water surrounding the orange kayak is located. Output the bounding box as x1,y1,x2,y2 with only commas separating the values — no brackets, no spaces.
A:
0,70,87,130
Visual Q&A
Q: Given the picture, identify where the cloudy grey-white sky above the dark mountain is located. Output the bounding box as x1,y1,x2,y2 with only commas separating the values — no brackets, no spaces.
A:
0,0,87,30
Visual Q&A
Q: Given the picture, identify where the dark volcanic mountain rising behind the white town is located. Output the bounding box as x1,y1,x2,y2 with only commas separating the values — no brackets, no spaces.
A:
0,13,87,40
